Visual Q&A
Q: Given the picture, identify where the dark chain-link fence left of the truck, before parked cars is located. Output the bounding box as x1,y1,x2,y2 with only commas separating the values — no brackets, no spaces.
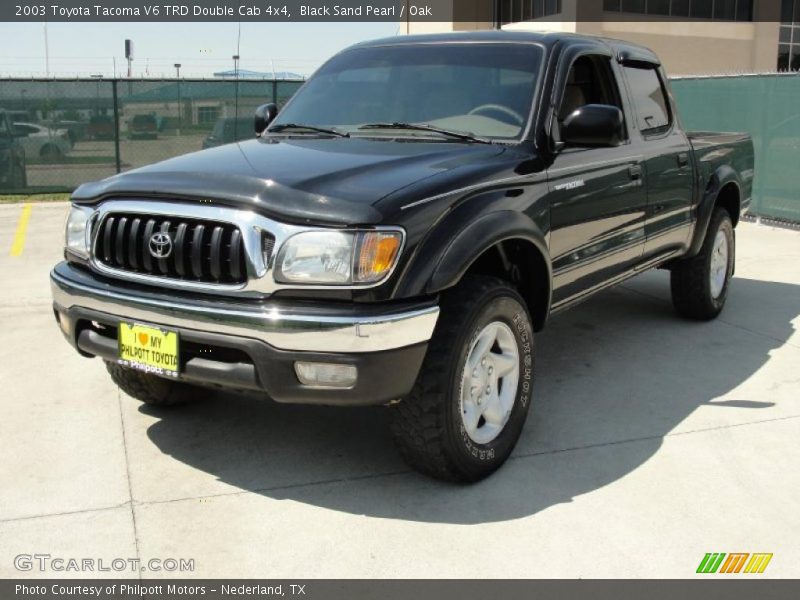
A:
0,78,303,193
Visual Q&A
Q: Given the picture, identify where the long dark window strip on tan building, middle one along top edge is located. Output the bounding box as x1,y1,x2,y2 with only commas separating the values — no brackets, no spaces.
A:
603,0,753,21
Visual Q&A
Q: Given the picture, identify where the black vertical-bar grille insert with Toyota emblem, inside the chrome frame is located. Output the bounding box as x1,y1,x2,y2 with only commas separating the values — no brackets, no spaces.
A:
94,212,260,285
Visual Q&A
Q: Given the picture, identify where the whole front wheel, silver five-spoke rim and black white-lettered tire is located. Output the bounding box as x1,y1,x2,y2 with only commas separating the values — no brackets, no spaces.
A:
392,276,533,482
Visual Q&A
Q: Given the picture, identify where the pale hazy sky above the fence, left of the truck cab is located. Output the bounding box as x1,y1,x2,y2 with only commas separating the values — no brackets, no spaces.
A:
0,22,399,77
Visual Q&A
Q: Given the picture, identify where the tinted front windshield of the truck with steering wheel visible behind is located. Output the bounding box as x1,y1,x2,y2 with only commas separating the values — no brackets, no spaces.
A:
270,43,542,141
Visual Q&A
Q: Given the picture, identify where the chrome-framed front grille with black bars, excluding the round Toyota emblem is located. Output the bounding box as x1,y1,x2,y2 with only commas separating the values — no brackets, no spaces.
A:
89,198,404,298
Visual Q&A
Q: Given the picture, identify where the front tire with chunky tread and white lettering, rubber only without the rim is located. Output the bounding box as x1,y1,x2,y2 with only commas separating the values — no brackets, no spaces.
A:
392,276,533,482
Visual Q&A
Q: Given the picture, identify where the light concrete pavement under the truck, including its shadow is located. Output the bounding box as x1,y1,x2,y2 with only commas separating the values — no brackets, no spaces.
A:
0,204,800,578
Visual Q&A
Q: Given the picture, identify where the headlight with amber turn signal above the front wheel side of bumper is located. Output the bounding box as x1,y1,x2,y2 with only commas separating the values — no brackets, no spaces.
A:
275,231,403,285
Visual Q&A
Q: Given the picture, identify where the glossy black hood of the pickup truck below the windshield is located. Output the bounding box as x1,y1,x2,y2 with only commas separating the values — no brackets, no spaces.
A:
73,138,506,225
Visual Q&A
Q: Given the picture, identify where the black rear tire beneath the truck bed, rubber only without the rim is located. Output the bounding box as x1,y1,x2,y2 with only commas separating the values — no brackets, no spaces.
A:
670,208,736,321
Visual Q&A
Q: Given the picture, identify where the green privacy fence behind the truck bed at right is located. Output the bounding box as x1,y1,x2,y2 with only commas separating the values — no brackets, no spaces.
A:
672,74,800,222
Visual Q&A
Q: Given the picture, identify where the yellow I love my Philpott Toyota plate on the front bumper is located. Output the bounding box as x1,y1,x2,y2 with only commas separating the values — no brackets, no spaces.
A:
119,323,179,377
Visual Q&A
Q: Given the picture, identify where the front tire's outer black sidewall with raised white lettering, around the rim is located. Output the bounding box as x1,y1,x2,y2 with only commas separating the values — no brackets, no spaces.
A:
445,286,534,478
